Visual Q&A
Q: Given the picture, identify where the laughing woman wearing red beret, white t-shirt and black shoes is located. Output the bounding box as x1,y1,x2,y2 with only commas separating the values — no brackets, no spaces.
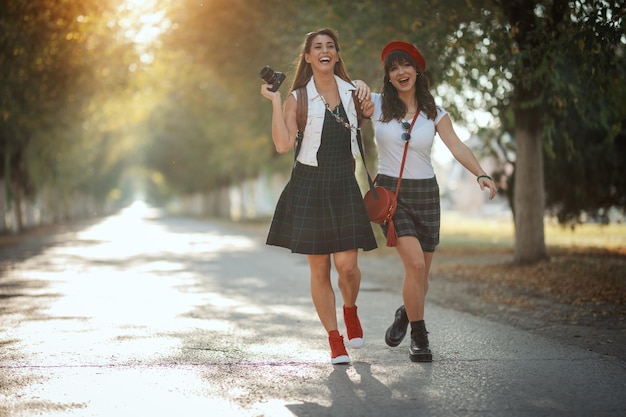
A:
371,41,497,362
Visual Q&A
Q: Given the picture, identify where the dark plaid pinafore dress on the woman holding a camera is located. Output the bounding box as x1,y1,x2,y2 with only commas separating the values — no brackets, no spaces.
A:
267,104,376,255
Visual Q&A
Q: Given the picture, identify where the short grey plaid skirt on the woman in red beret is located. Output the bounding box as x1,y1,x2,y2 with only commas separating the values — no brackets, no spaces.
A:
376,175,441,252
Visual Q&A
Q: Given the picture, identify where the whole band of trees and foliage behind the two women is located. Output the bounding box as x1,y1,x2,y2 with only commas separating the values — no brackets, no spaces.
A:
0,0,626,262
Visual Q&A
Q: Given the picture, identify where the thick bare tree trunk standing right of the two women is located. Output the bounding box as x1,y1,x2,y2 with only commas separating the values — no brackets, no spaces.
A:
513,109,547,264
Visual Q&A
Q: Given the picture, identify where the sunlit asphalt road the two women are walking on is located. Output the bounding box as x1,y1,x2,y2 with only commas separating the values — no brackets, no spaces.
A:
0,203,626,417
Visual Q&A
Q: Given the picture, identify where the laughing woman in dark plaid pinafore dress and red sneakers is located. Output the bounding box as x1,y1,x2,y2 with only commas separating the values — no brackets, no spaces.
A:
261,29,376,364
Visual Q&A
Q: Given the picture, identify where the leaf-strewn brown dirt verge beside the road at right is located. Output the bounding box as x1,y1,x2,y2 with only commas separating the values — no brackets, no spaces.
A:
361,245,626,360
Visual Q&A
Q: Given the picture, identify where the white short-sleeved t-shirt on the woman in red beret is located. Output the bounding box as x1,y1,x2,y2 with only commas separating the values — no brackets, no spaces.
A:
371,93,448,179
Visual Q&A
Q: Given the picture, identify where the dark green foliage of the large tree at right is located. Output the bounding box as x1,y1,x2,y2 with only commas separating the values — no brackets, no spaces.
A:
424,0,626,223
